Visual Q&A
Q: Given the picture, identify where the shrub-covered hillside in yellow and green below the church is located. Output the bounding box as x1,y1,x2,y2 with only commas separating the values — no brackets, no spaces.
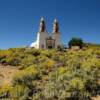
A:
0,47,100,100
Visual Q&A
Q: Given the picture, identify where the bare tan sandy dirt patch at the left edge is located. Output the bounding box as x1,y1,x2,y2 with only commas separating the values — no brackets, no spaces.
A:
0,65,18,85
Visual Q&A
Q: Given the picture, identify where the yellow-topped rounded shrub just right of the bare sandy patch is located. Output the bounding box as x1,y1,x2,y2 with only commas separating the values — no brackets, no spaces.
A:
13,66,40,85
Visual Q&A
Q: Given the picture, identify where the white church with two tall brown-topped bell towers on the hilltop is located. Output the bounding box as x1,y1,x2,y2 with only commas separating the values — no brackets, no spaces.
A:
30,17,61,49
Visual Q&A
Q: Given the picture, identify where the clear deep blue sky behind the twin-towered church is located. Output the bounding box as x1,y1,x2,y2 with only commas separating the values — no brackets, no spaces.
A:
0,0,100,49
